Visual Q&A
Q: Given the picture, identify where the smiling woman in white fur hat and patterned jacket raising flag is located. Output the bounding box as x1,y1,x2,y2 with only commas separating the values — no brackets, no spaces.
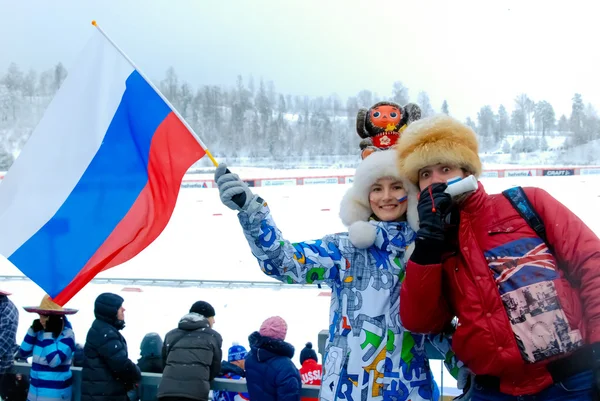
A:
215,150,462,401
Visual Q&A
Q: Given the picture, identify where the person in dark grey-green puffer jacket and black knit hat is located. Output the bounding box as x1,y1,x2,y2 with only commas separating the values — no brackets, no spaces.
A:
158,301,223,401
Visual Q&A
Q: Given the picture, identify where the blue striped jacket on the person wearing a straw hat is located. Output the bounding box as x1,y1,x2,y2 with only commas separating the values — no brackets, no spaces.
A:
19,317,75,401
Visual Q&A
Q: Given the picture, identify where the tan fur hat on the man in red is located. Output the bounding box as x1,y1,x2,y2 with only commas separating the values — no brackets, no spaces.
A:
396,114,482,186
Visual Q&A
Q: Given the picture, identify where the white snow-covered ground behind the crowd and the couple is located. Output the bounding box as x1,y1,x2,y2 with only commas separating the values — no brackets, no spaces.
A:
0,173,600,396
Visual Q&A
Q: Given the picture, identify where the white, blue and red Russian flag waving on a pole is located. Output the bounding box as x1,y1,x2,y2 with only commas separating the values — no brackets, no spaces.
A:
0,29,207,305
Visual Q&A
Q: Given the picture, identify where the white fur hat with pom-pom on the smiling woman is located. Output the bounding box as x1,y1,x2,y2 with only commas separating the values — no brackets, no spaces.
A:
340,148,419,249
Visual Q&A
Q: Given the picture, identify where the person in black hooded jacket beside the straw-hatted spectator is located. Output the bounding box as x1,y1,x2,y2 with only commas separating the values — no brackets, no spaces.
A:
81,293,141,401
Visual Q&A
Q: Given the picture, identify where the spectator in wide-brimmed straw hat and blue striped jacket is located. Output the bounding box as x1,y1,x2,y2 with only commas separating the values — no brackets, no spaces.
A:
19,295,77,401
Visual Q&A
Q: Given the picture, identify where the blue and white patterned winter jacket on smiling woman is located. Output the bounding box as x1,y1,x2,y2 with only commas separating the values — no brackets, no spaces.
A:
238,203,458,401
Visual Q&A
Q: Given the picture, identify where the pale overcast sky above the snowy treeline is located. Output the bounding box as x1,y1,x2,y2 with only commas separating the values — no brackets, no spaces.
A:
0,0,600,119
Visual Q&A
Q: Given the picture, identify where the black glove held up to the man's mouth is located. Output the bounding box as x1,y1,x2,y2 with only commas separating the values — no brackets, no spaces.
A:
417,183,452,241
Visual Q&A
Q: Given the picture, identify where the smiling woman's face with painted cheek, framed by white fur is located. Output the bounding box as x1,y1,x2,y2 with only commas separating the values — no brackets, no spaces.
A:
369,177,408,221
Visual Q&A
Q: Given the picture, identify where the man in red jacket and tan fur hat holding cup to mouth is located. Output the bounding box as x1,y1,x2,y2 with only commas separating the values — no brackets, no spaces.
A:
397,115,600,400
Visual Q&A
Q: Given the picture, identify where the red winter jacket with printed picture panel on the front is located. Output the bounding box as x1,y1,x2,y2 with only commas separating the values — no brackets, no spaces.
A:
400,183,600,395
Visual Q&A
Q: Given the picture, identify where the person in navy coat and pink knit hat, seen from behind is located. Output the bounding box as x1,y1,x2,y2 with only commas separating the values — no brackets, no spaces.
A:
246,316,302,401
